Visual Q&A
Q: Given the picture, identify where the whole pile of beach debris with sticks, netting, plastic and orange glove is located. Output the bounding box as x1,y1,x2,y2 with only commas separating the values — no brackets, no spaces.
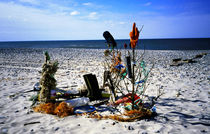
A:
30,23,163,122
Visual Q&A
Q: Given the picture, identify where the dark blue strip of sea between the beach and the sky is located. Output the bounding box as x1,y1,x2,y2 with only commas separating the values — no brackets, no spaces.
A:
0,38,210,50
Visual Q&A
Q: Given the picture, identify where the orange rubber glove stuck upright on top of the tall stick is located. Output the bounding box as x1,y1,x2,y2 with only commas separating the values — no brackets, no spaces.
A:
129,22,139,48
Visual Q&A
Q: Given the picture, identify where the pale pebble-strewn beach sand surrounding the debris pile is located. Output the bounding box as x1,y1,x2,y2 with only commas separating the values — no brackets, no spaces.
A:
0,48,210,134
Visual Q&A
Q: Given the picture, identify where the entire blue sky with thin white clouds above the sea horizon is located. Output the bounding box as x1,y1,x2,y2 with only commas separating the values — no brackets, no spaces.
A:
0,0,210,41
